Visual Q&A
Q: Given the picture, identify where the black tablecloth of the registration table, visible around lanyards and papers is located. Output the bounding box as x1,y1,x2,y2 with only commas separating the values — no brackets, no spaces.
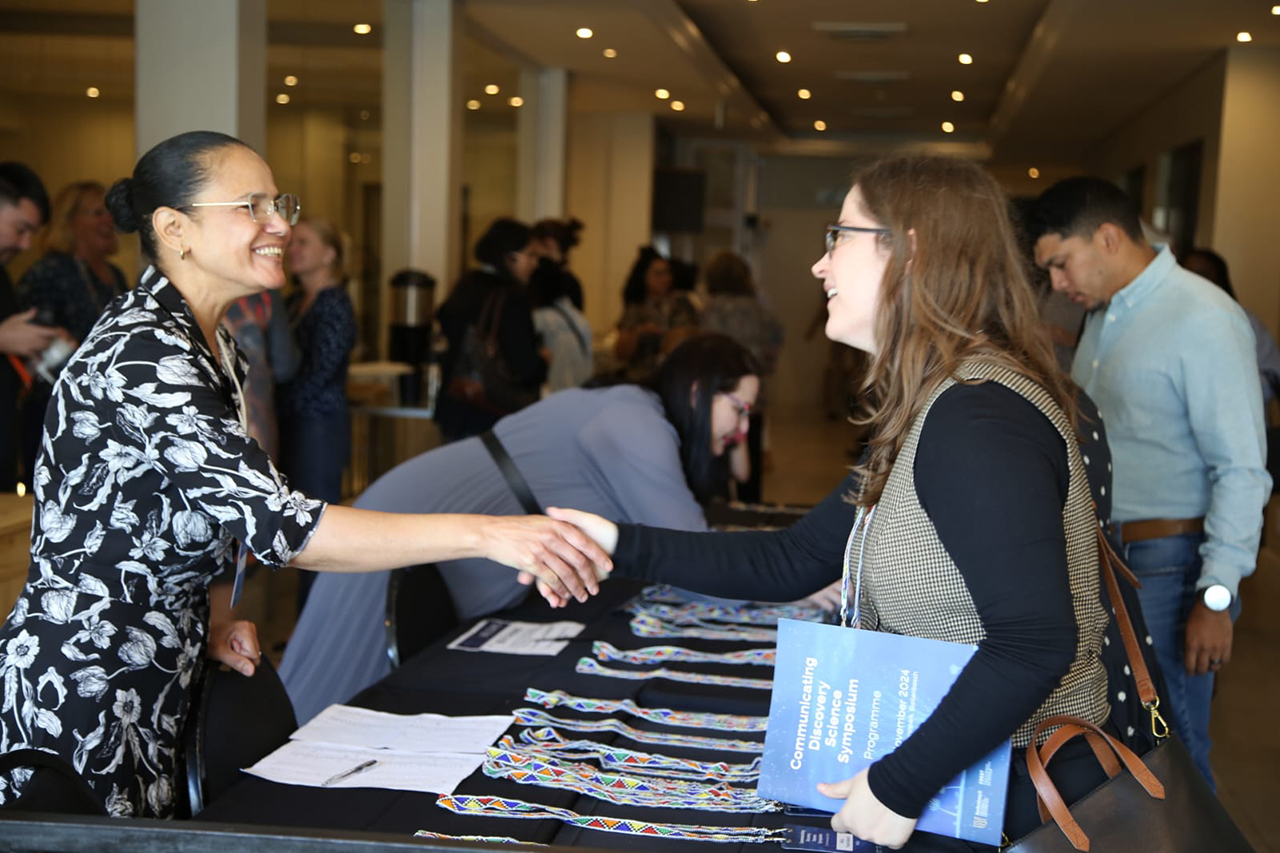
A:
196,579,827,850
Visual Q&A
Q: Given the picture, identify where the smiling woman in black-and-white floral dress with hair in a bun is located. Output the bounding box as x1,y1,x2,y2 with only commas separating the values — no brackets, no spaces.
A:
0,132,609,817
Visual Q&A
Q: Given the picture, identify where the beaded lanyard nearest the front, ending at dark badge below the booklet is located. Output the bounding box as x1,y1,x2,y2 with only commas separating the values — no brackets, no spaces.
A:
435,794,788,844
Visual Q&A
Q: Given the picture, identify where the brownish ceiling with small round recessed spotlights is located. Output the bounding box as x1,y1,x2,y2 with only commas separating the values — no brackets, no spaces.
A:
0,0,1280,163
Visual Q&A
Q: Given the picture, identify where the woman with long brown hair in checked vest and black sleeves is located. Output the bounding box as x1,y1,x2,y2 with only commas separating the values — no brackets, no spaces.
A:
548,156,1108,850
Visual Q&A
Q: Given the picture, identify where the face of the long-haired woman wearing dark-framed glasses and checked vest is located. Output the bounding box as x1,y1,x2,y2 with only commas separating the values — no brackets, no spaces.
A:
813,186,891,352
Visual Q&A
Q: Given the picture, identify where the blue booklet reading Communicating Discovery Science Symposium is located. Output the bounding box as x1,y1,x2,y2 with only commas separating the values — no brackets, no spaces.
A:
759,619,1011,845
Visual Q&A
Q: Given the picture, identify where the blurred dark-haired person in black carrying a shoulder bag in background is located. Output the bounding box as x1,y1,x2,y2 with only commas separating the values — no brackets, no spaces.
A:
435,219,547,441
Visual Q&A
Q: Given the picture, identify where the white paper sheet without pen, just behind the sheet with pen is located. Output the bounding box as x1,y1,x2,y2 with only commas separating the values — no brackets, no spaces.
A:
292,704,512,754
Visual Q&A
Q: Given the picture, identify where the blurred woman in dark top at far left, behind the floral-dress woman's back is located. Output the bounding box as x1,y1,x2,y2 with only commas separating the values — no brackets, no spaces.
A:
18,181,127,488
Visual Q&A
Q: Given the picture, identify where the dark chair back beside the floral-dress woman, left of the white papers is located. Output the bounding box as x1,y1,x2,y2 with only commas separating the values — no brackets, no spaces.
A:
183,657,298,816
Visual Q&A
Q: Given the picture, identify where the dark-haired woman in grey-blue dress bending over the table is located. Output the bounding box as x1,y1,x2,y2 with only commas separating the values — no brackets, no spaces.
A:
280,334,762,721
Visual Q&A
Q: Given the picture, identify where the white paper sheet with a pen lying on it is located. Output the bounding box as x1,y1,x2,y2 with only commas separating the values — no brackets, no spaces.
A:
244,740,484,794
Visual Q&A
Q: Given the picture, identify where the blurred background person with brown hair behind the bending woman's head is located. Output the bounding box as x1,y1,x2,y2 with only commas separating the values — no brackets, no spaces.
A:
701,245,783,503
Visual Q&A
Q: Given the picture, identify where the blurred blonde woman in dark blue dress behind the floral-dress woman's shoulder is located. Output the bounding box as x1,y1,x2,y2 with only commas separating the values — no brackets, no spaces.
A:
279,212,356,612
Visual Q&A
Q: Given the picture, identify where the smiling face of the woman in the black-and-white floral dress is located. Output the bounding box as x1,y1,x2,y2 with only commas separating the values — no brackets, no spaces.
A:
179,145,291,292
